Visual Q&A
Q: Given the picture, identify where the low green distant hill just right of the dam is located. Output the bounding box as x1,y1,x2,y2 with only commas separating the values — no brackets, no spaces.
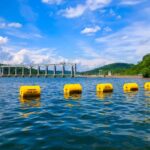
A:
81,63,134,75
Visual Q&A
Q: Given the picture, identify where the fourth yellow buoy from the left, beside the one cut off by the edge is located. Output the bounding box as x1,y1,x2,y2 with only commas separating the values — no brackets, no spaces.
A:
123,83,139,92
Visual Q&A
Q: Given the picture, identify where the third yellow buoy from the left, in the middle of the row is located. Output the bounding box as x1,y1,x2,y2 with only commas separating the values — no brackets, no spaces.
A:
96,83,113,93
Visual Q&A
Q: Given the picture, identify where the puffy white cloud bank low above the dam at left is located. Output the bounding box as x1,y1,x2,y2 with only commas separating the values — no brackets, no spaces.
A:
0,46,67,64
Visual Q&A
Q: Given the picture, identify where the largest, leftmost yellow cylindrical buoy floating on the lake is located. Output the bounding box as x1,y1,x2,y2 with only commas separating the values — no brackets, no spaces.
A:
20,85,41,97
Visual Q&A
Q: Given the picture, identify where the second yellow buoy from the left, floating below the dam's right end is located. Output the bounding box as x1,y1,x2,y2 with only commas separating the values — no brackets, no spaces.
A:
64,84,82,94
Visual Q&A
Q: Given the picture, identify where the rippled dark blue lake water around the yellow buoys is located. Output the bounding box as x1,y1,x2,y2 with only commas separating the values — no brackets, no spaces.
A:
0,78,150,150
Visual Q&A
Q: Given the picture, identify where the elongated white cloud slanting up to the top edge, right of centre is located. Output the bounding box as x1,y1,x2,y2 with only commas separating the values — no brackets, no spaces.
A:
61,0,111,18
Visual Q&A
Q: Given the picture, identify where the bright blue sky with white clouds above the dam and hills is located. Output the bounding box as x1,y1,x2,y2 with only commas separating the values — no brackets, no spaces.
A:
0,0,150,70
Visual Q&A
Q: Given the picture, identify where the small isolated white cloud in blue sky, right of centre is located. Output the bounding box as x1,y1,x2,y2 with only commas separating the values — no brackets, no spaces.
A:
81,26,101,35
